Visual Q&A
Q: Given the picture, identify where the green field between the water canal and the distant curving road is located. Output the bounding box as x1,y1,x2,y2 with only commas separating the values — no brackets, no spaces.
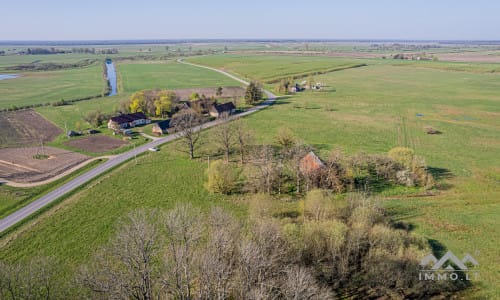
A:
117,61,241,93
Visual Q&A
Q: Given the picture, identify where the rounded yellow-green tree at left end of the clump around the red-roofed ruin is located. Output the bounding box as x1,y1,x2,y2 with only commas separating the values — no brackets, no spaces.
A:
206,160,240,195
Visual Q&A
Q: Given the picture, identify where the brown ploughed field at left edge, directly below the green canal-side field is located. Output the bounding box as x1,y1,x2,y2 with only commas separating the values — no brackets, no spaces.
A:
0,109,63,148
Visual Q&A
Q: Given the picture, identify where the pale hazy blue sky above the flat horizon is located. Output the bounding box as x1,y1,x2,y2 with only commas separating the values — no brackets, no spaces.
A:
0,0,500,40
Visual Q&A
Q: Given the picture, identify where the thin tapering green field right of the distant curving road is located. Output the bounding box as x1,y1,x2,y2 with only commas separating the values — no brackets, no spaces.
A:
189,54,365,82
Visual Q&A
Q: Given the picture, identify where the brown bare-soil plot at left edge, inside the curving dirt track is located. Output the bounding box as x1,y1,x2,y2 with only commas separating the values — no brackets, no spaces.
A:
0,147,89,183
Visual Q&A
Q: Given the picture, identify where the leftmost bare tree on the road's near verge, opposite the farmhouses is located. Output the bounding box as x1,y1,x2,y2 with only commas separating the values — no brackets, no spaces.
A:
173,110,203,159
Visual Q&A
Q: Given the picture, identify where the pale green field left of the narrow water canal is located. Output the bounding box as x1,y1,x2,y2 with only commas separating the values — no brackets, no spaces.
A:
0,64,106,109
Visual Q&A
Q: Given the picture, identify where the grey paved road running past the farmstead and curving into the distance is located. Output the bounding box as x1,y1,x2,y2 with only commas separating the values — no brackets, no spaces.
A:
0,60,276,232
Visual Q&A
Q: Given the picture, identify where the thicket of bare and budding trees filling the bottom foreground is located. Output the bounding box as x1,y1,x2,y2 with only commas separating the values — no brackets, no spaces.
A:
0,196,466,299
